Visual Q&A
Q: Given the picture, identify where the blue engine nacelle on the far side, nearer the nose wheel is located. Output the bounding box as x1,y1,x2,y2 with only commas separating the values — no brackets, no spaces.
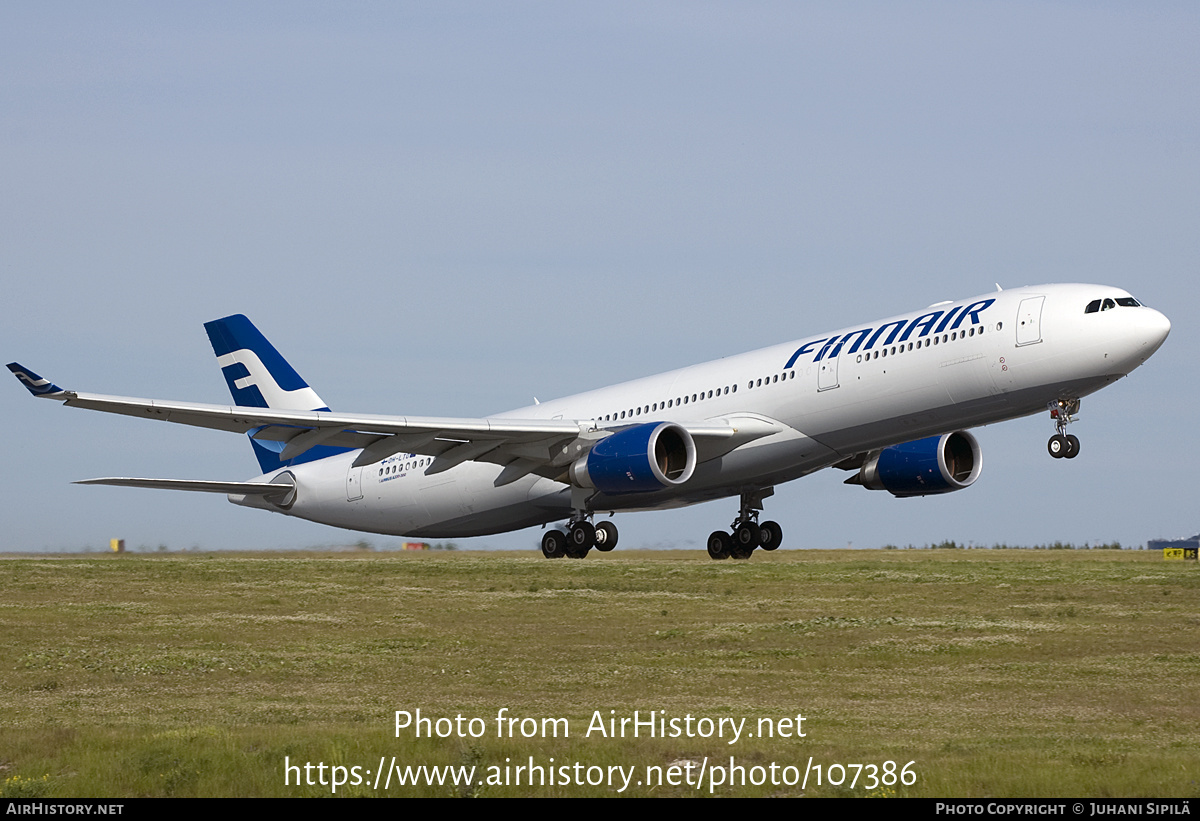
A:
854,431,983,497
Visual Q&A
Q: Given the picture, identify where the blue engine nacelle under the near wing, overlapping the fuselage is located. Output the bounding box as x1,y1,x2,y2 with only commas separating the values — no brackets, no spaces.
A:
570,423,696,496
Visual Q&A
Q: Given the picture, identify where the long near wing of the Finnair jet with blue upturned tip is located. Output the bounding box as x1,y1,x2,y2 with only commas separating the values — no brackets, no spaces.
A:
8,362,744,484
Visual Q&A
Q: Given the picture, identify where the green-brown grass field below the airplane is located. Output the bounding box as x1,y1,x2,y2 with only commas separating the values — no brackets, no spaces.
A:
0,550,1200,797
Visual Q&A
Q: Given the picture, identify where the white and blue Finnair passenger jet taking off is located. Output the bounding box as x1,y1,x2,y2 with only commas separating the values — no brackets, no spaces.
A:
8,284,1171,559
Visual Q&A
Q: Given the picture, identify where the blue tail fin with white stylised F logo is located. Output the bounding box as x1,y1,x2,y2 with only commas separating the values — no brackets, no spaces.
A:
204,313,350,473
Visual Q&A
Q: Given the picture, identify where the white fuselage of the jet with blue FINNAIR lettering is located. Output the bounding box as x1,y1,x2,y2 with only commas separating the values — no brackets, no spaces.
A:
238,284,1170,538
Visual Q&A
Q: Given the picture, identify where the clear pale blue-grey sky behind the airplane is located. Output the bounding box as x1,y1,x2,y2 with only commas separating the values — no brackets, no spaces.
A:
0,2,1200,550
